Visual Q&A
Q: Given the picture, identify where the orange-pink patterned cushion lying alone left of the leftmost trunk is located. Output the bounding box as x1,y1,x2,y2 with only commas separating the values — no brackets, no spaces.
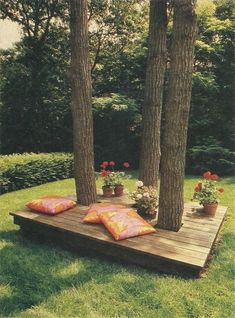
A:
26,195,76,215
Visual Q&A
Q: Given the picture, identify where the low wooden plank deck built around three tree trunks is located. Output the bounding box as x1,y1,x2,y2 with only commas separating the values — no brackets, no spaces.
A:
10,198,227,277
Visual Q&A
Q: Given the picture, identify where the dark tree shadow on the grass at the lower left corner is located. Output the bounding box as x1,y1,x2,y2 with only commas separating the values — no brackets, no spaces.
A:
0,231,125,317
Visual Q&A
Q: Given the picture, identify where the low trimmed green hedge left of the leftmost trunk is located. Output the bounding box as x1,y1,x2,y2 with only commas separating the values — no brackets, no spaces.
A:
0,153,73,194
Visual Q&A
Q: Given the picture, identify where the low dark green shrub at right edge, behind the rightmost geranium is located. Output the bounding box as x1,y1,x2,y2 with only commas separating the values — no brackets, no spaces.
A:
187,145,235,175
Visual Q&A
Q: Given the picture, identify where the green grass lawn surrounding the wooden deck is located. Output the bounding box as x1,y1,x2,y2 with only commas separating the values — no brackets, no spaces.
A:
0,177,235,318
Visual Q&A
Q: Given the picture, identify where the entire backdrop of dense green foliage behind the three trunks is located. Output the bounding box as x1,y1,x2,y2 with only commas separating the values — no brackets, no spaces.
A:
0,0,235,174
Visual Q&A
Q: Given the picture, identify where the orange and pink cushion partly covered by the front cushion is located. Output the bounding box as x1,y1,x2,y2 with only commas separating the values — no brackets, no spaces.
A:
83,203,125,223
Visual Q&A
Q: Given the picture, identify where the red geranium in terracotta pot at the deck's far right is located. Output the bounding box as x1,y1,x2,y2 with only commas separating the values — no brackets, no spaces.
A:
193,171,224,216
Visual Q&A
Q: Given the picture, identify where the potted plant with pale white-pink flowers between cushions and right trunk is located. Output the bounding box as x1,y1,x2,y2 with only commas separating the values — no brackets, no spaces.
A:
130,181,158,219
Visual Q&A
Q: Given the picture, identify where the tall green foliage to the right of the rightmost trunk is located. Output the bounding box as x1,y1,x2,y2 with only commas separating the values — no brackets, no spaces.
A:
187,0,235,175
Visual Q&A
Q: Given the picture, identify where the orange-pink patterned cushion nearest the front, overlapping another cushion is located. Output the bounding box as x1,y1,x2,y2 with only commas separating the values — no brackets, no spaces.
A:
100,209,156,241
